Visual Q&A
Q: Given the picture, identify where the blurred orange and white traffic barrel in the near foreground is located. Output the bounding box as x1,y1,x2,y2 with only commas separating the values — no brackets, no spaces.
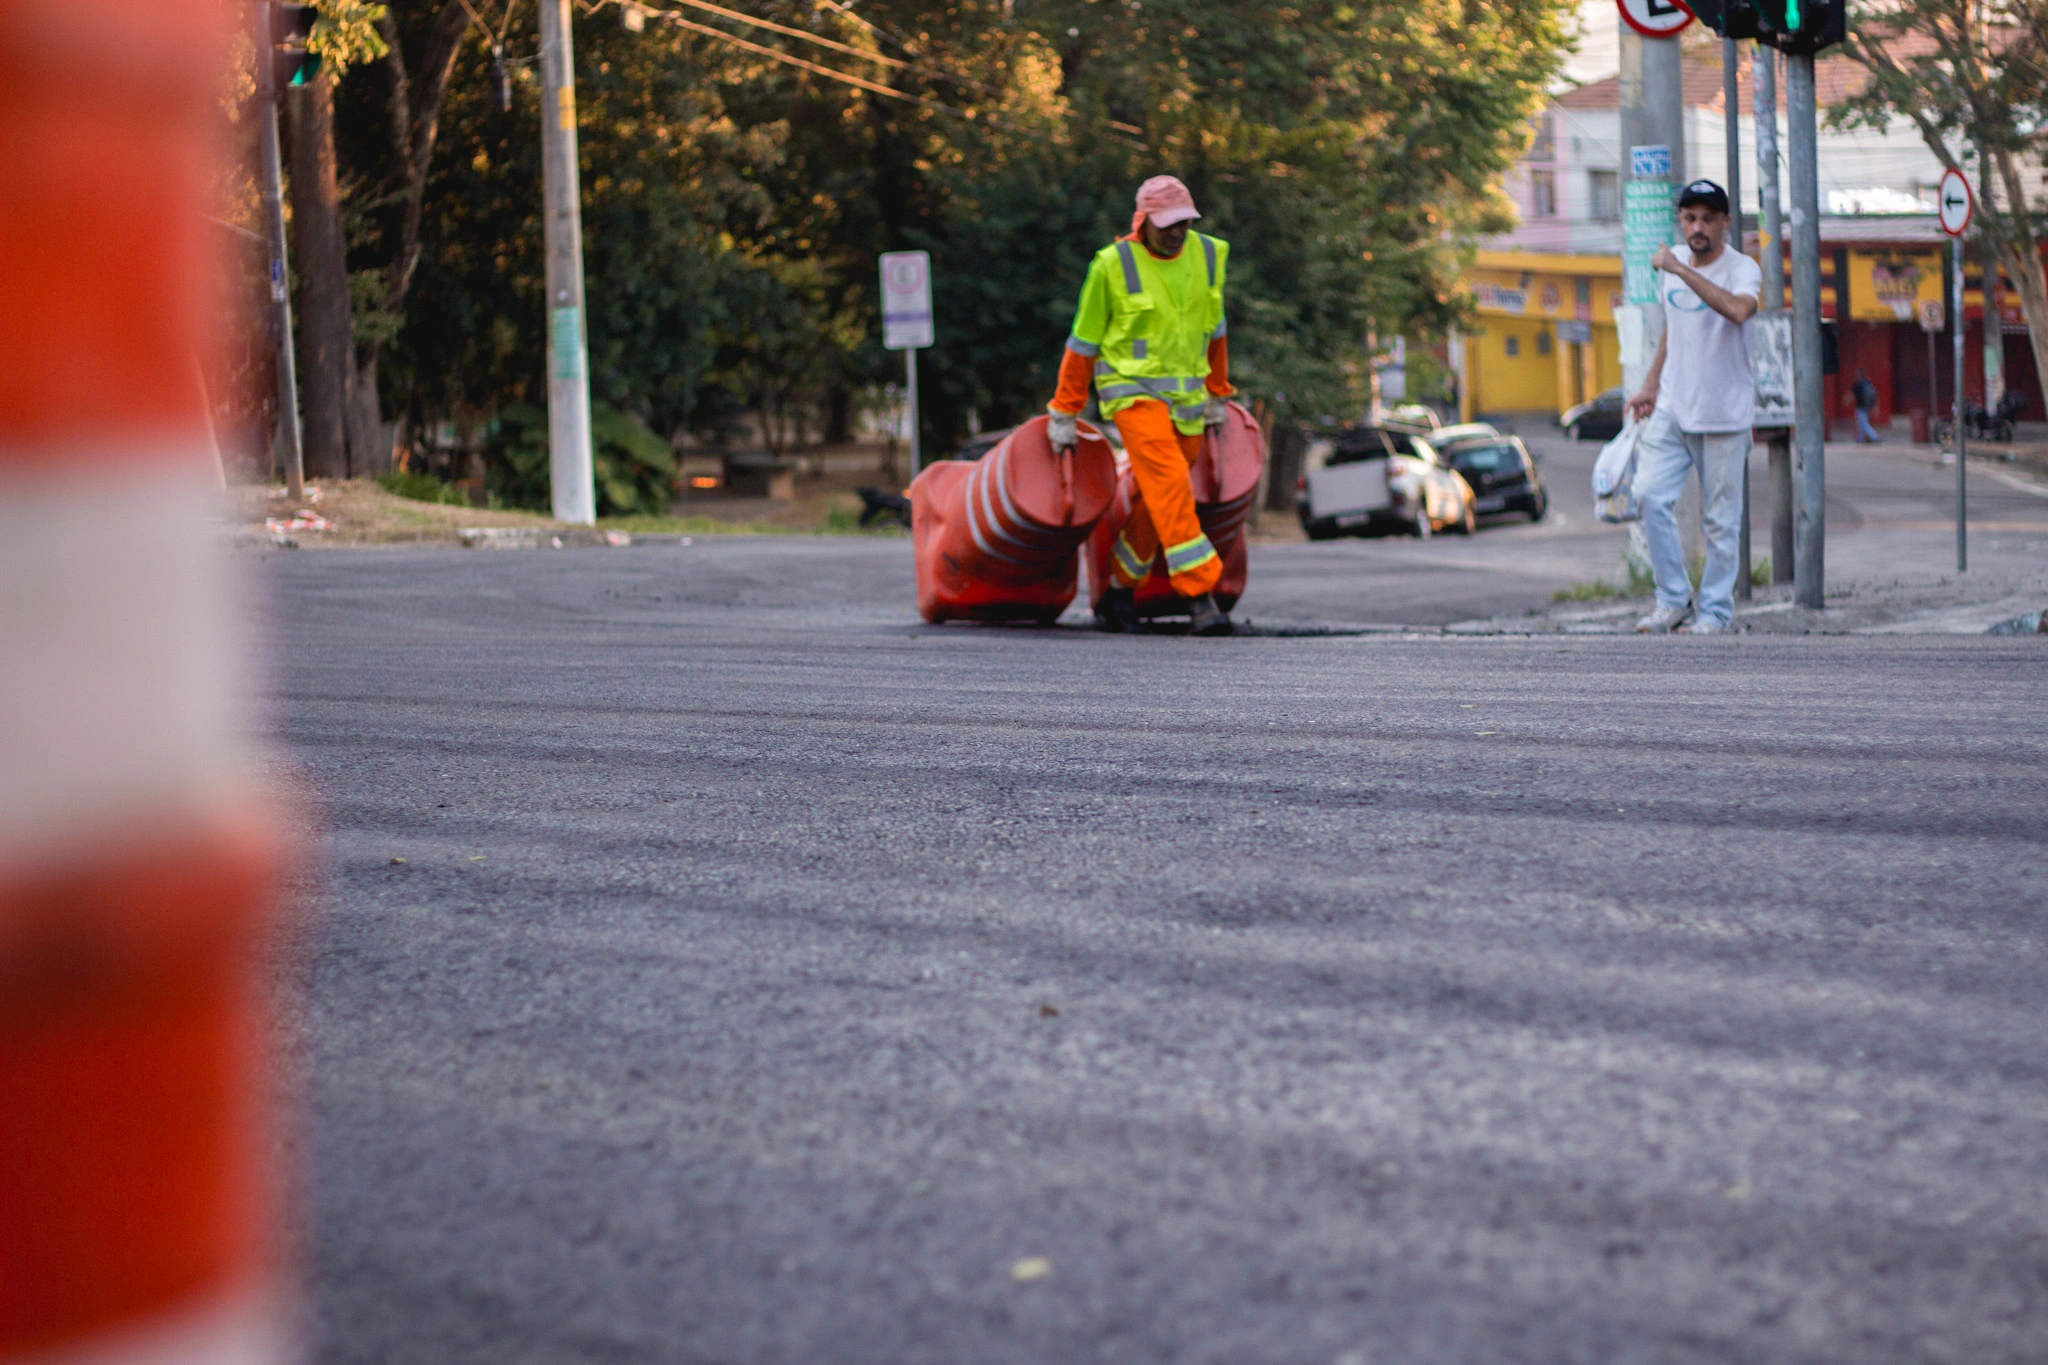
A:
0,0,289,1365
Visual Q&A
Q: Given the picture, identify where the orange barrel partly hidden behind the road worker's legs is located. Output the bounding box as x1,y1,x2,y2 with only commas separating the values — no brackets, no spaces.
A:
1087,403,1266,616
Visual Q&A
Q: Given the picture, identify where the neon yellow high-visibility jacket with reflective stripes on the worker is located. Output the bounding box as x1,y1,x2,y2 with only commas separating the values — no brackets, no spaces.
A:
1067,233,1231,436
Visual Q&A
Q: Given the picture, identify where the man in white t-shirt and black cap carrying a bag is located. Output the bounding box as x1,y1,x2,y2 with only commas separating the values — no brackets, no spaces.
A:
1628,180,1763,634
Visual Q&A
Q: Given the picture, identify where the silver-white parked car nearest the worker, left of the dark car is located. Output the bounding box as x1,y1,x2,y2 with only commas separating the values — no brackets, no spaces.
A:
1294,426,1475,540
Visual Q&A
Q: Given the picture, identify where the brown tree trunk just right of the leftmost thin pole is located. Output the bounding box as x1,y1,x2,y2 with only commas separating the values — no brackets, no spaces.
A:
291,76,356,479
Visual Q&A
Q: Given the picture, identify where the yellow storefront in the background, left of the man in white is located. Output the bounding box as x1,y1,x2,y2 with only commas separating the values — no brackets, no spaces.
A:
1458,252,1622,422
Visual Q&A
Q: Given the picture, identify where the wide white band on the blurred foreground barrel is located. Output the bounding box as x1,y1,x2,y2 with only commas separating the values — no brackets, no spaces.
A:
0,458,248,864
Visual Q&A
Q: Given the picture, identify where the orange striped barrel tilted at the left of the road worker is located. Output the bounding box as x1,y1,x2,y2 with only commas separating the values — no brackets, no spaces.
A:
909,417,1116,624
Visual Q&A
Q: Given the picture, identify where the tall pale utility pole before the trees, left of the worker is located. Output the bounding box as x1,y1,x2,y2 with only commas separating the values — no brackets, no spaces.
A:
541,0,598,526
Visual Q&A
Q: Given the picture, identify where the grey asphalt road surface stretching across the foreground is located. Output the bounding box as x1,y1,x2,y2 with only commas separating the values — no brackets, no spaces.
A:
272,536,2048,1365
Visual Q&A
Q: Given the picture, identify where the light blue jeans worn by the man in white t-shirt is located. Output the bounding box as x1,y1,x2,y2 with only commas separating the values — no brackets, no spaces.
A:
1636,409,1749,626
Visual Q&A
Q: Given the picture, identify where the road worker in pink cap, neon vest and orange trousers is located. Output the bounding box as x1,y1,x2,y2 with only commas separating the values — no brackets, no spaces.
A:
1047,176,1235,634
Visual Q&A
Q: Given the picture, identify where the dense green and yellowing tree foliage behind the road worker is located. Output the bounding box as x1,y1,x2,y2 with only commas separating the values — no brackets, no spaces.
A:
338,0,1565,464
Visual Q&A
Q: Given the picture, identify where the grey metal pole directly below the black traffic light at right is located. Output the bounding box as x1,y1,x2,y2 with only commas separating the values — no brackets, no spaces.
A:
1786,53,1827,610
